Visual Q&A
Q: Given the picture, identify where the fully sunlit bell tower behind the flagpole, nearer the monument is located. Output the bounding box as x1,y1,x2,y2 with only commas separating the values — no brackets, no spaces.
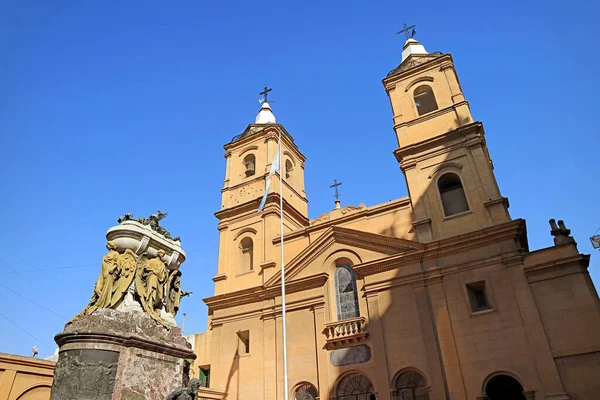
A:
213,100,308,295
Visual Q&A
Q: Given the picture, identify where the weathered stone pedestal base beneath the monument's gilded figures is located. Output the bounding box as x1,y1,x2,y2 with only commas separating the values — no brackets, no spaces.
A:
50,309,196,400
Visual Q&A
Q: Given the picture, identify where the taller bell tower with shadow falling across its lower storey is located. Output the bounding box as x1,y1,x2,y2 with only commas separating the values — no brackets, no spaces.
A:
383,37,510,242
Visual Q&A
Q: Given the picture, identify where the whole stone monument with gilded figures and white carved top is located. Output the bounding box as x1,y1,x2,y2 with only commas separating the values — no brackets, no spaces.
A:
50,210,196,400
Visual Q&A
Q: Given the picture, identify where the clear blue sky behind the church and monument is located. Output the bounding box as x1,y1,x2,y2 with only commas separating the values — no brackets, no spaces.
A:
0,1,600,356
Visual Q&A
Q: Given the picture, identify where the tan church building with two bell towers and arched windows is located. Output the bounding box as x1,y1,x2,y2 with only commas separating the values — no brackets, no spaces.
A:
189,39,600,400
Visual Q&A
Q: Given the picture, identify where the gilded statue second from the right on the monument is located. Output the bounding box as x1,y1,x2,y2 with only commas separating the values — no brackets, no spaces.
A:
135,250,168,325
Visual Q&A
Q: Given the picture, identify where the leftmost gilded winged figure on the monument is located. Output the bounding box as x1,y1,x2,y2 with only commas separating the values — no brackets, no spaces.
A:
73,241,120,320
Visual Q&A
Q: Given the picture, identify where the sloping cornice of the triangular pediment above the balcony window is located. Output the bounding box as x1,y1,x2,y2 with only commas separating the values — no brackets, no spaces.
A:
264,226,425,288
